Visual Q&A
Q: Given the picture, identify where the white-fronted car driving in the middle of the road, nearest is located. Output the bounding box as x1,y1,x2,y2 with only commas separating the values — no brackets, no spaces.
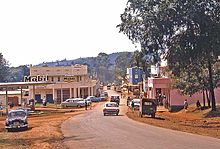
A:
103,102,119,116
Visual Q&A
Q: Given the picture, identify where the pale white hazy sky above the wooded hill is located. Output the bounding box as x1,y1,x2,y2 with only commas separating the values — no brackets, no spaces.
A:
0,0,138,66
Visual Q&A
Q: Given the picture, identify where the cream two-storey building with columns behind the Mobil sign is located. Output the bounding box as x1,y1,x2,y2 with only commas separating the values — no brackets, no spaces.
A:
27,65,98,103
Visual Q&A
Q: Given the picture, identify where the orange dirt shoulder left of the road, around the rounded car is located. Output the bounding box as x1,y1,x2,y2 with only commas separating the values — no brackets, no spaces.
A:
0,108,84,149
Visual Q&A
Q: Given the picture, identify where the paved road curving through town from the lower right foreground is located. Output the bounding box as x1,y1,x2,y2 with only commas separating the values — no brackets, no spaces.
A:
61,89,220,149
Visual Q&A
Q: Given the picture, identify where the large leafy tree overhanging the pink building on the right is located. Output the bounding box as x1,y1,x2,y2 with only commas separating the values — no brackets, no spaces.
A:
118,0,220,110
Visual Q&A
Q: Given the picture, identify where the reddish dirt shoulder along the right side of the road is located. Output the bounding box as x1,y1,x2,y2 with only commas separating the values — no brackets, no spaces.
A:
126,107,220,139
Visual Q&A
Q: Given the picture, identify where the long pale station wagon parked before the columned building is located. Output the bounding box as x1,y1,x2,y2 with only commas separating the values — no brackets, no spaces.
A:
61,98,86,108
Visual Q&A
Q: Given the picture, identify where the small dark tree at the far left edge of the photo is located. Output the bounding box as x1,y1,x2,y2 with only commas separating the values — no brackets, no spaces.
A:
0,53,9,82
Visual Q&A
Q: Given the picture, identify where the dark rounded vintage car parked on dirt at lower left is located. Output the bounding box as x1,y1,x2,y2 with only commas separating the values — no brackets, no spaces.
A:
5,109,28,131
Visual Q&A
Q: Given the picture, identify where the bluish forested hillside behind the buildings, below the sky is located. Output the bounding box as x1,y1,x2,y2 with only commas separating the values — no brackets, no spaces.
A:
7,52,133,83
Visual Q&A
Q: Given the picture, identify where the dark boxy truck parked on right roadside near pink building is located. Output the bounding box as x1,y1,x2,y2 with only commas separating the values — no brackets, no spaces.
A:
139,98,157,118
